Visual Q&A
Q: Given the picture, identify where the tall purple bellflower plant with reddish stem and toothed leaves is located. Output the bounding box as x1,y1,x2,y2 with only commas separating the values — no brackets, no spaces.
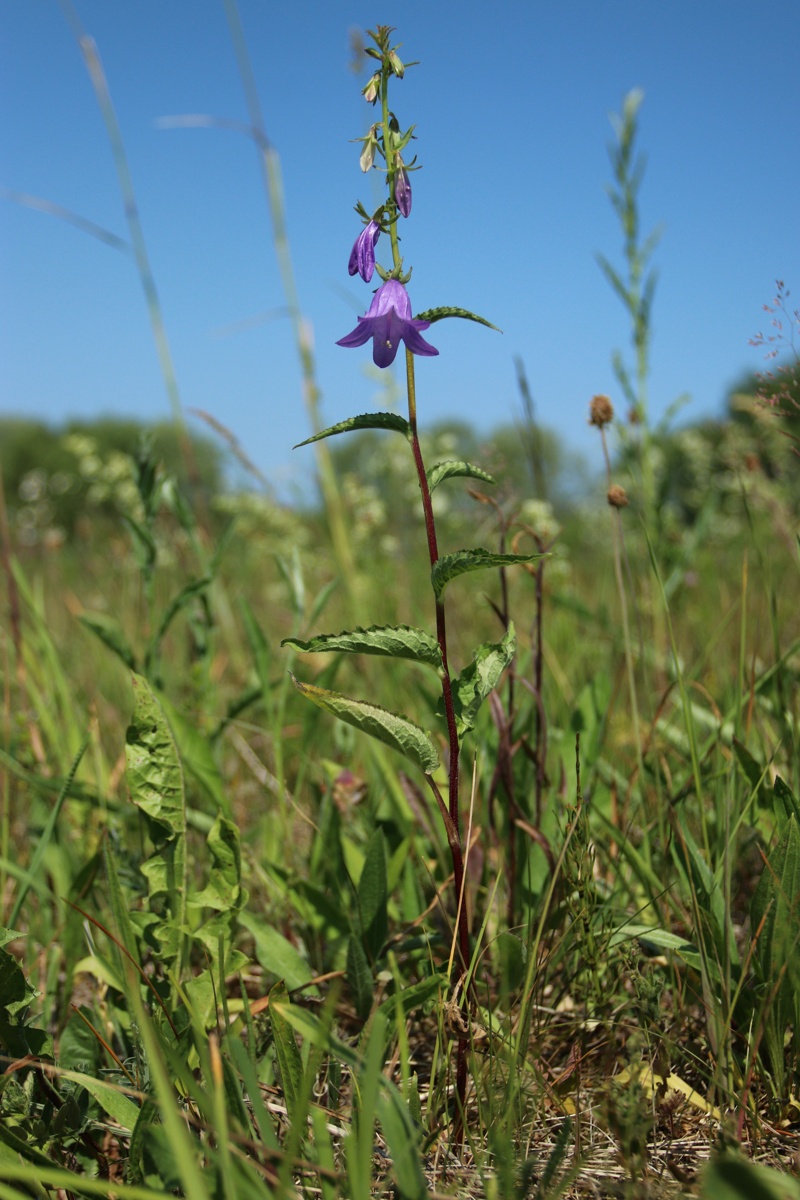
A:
284,25,541,1141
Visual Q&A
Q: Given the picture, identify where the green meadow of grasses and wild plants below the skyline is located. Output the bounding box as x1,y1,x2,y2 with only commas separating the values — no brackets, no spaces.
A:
0,11,800,1200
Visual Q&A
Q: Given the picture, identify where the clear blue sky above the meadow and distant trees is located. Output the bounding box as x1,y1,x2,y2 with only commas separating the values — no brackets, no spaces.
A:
0,0,800,493
